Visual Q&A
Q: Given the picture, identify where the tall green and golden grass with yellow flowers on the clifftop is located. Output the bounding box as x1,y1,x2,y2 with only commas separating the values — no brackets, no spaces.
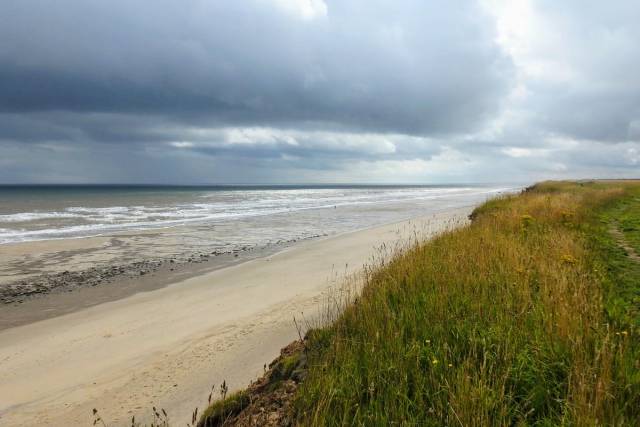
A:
295,183,640,426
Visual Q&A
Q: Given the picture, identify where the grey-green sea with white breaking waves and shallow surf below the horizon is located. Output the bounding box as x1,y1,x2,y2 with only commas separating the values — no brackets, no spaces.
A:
0,185,520,246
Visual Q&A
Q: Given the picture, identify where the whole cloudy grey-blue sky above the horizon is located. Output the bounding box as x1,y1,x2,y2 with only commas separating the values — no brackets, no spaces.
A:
0,0,640,184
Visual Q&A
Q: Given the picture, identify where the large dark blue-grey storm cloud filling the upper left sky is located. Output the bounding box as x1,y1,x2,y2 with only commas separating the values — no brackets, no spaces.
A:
0,0,510,134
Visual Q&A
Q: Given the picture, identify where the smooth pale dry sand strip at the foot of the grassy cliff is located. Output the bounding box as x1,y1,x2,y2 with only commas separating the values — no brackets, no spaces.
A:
0,208,470,426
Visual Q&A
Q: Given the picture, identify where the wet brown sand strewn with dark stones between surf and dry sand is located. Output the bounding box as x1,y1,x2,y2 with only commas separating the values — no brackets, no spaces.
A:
0,227,325,331
